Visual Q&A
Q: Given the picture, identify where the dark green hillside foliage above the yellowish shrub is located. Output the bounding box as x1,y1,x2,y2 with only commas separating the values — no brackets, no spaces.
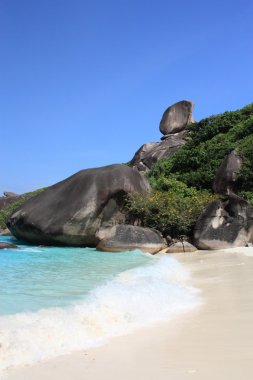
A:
148,104,253,192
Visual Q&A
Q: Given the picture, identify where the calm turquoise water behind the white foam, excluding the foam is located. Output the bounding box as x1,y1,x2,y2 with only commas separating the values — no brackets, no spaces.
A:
0,237,152,315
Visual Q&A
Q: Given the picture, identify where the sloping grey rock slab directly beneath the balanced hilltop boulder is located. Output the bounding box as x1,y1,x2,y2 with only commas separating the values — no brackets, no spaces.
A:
130,131,186,172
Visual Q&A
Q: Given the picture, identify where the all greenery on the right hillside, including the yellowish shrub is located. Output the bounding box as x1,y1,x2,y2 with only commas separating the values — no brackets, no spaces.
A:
128,104,253,237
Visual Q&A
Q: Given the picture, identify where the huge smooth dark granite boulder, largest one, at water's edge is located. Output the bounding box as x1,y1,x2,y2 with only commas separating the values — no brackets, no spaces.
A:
7,165,150,246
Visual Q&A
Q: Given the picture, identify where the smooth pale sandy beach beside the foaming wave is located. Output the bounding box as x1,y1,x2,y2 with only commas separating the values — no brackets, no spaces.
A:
2,248,253,380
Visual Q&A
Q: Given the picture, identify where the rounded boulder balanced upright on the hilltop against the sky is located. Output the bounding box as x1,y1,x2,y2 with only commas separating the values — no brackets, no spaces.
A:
160,100,194,135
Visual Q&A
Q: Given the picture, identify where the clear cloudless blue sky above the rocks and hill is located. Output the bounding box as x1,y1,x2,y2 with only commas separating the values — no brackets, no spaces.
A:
0,0,253,193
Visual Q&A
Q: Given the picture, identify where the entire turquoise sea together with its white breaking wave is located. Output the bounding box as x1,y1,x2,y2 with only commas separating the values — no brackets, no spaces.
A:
0,237,199,377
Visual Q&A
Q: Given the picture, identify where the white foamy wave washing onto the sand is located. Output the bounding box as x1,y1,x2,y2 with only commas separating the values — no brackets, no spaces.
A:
0,256,200,369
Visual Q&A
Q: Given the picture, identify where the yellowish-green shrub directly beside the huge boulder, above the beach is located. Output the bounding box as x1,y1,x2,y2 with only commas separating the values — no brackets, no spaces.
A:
127,182,216,237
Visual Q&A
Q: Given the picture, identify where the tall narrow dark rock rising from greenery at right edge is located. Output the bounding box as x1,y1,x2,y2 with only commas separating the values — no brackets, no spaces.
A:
213,151,242,195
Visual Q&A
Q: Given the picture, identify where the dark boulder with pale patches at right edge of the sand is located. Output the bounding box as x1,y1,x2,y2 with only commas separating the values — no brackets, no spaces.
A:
194,195,253,249
